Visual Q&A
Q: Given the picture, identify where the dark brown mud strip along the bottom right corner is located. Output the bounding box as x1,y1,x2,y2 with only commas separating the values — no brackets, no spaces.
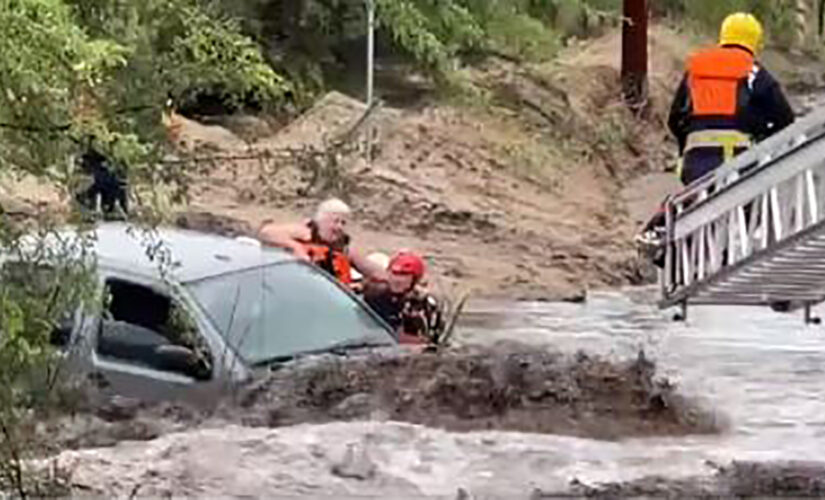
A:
548,462,825,500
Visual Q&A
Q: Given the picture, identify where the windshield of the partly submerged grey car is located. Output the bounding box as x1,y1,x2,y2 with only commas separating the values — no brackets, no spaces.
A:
187,262,394,365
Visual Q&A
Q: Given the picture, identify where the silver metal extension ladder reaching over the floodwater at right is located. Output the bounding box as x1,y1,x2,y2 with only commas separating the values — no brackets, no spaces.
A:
659,107,825,321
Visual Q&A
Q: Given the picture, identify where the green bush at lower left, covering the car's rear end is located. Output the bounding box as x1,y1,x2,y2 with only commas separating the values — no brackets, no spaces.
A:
0,225,96,497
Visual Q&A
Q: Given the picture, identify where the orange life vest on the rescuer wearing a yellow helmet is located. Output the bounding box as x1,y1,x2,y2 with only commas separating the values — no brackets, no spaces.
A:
687,47,754,117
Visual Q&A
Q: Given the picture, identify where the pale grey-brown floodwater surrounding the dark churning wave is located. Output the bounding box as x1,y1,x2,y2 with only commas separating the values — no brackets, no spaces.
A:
61,290,825,498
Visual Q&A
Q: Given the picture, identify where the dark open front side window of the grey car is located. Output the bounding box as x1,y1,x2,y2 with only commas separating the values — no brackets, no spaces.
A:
97,278,213,380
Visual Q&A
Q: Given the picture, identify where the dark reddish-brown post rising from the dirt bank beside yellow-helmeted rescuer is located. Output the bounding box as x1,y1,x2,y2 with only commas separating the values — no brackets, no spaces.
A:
622,0,648,112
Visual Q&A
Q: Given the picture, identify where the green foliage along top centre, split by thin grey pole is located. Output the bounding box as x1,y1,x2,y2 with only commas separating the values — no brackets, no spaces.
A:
221,0,604,99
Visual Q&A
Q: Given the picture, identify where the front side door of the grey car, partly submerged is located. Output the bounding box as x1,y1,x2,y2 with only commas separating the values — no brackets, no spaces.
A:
90,269,232,404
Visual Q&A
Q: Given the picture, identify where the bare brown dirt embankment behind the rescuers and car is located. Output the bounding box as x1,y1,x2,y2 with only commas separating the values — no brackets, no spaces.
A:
167,27,700,299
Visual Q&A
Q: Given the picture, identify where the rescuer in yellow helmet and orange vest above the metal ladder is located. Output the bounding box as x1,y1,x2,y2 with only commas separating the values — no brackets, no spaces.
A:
637,12,795,267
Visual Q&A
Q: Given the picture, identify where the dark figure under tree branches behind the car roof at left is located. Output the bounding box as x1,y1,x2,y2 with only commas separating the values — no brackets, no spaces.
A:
76,147,129,215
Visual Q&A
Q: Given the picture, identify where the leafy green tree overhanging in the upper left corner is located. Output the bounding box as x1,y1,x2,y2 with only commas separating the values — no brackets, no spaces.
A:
0,0,288,197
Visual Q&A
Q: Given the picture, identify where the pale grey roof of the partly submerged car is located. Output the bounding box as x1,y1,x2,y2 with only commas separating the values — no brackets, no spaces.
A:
33,222,297,283
